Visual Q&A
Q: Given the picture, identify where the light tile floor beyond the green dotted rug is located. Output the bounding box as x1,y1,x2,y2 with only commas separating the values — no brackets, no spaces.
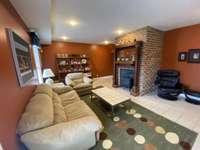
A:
94,76,200,150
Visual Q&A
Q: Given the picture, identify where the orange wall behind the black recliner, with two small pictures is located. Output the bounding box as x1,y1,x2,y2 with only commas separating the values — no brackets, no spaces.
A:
161,24,200,92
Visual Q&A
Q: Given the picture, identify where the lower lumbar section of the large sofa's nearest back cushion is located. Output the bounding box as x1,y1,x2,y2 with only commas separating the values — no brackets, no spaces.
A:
54,103,67,124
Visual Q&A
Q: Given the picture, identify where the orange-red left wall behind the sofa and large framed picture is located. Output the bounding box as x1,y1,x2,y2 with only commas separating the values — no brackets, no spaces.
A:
0,0,34,150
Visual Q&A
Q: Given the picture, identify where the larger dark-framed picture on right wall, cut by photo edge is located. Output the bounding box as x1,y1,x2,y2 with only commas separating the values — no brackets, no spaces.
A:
188,49,200,63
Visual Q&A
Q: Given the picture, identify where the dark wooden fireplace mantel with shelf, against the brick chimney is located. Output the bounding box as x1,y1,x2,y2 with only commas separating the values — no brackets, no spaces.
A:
113,41,143,96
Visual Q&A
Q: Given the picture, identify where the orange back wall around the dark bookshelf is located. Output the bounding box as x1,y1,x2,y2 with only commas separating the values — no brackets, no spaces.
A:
42,42,113,76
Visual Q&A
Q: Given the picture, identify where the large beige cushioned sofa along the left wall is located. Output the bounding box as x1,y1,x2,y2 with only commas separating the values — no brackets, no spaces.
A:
17,84,103,150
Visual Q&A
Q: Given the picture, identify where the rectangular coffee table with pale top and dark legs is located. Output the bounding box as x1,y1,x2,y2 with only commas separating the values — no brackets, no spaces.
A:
91,87,131,114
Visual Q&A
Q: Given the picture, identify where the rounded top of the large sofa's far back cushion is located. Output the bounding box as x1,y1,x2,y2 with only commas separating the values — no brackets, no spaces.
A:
33,84,53,98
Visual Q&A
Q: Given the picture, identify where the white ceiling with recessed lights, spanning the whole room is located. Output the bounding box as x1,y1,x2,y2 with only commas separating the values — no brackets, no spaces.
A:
11,0,200,43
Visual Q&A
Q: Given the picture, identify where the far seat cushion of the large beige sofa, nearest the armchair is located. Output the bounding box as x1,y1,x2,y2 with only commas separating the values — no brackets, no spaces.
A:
59,90,80,106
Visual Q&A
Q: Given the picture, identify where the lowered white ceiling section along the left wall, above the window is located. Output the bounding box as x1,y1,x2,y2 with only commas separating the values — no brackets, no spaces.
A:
10,0,52,44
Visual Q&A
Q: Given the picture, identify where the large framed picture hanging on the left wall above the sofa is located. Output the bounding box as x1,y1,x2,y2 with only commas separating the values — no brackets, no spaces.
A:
7,29,34,87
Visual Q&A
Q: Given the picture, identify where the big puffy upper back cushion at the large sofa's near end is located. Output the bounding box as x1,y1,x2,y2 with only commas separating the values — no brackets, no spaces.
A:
17,94,54,135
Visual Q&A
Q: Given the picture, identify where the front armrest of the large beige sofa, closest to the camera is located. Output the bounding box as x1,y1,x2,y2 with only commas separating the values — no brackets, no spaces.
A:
21,116,103,150
